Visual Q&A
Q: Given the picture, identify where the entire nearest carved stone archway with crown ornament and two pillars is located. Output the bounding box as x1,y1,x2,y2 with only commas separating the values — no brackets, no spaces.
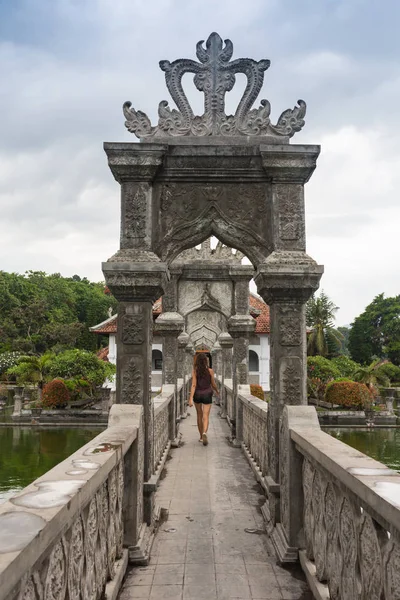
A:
103,33,323,540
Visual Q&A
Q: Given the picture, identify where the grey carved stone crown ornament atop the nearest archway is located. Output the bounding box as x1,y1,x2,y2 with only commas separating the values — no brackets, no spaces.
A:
123,32,306,141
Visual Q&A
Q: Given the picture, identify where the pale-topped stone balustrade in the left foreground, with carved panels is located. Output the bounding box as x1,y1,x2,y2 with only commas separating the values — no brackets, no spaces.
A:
0,405,144,600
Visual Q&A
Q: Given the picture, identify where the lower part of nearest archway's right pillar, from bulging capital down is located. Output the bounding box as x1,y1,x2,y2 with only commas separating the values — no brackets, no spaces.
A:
255,252,322,554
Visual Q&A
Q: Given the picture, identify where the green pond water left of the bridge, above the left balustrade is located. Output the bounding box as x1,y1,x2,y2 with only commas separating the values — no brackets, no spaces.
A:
0,427,101,502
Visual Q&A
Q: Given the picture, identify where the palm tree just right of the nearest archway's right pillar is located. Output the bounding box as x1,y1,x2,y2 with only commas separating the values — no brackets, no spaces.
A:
306,291,343,356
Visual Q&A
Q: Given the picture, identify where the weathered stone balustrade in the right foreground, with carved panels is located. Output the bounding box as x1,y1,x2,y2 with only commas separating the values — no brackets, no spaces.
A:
280,406,400,600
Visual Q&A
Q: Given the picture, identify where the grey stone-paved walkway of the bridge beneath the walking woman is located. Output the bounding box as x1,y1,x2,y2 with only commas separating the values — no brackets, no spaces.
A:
119,406,313,600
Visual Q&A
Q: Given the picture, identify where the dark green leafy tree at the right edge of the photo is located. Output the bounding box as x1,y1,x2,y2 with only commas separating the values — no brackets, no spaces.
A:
349,294,400,365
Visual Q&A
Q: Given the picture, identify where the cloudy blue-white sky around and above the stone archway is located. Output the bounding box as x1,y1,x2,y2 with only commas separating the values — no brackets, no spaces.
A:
0,0,400,324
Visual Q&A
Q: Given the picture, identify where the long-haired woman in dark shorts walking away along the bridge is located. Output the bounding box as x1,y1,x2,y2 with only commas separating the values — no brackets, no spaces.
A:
189,353,219,446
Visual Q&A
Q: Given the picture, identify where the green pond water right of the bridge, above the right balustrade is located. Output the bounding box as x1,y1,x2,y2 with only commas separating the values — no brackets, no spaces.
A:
324,427,400,472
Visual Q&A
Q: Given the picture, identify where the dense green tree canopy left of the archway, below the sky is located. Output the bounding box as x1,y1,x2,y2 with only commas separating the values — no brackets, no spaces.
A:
0,271,116,354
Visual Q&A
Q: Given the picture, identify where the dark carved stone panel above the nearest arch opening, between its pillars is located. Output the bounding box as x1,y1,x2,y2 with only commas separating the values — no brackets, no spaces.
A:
157,182,270,262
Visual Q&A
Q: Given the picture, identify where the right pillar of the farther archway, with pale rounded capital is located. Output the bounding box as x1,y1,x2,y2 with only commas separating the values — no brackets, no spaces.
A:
228,314,256,444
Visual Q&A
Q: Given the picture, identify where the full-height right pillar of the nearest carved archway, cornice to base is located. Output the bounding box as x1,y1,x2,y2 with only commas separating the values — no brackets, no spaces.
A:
254,146,323,544
